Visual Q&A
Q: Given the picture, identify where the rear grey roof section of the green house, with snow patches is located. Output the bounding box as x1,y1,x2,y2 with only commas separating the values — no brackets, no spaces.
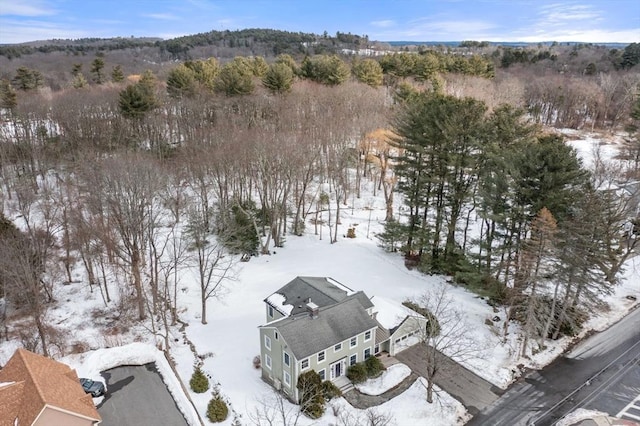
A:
264,277,373,316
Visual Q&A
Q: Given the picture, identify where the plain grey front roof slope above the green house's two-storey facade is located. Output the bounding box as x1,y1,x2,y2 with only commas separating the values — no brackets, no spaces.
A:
263,292,378,360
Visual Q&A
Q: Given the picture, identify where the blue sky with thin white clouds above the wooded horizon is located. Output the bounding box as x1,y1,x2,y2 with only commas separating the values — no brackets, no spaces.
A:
0,0,640,43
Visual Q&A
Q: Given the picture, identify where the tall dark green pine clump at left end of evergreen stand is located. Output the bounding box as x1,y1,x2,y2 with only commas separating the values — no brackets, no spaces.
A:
393,92,486,270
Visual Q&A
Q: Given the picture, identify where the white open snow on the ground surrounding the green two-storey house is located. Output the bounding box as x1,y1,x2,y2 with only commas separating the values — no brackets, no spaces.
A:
0,131,640,426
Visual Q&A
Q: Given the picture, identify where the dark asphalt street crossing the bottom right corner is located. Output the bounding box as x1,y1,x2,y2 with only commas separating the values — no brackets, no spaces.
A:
467,309,640,426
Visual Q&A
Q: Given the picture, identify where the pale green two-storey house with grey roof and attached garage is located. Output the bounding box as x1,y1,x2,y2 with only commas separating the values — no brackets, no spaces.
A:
259,277,426,402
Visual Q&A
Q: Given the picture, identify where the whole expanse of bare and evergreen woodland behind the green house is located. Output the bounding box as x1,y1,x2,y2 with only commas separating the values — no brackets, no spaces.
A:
0,30,640,360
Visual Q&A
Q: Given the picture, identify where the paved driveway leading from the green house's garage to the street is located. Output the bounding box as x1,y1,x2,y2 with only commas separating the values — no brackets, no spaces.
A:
395,343,499,415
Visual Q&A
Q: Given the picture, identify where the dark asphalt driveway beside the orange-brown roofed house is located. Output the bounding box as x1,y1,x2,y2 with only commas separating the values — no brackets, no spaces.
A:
98,363,188,426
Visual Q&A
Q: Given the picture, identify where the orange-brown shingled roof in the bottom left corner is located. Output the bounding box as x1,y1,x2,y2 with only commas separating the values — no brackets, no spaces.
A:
0,349,101,425
